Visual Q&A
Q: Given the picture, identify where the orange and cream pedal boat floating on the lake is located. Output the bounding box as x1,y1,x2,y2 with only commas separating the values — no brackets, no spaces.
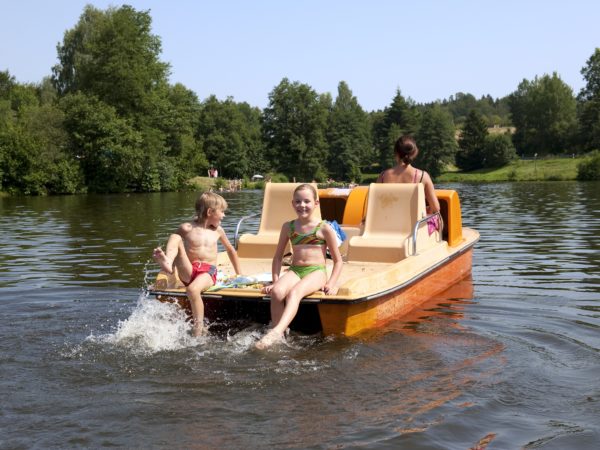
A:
149,183,479,336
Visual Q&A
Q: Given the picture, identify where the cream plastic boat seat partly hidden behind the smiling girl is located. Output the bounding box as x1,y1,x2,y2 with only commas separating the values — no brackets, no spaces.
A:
237,183,321,258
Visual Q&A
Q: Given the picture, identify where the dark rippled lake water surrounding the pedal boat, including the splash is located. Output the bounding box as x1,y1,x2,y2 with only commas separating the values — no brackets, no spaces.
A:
0,182,600,449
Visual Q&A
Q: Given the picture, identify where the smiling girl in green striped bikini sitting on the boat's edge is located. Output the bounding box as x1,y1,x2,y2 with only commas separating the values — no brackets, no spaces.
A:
256,184,342,349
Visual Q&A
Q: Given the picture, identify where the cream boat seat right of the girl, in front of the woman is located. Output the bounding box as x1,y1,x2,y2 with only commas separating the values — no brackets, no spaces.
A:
347,183,436,263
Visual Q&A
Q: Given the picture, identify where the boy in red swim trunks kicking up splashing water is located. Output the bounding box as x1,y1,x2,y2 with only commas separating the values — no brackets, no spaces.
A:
153,192,241,336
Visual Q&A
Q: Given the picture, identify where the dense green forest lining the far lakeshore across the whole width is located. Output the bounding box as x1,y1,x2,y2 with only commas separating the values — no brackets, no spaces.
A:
0,6,600,195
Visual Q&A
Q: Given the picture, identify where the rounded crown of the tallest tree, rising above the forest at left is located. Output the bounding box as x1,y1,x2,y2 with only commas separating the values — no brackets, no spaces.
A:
52,5,169,121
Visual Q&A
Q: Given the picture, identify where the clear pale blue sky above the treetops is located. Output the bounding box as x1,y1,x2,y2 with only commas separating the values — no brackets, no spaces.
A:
0,0,600,111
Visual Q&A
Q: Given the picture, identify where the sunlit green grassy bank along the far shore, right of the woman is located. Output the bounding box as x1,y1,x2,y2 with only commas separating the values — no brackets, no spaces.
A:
435,158,583,183
